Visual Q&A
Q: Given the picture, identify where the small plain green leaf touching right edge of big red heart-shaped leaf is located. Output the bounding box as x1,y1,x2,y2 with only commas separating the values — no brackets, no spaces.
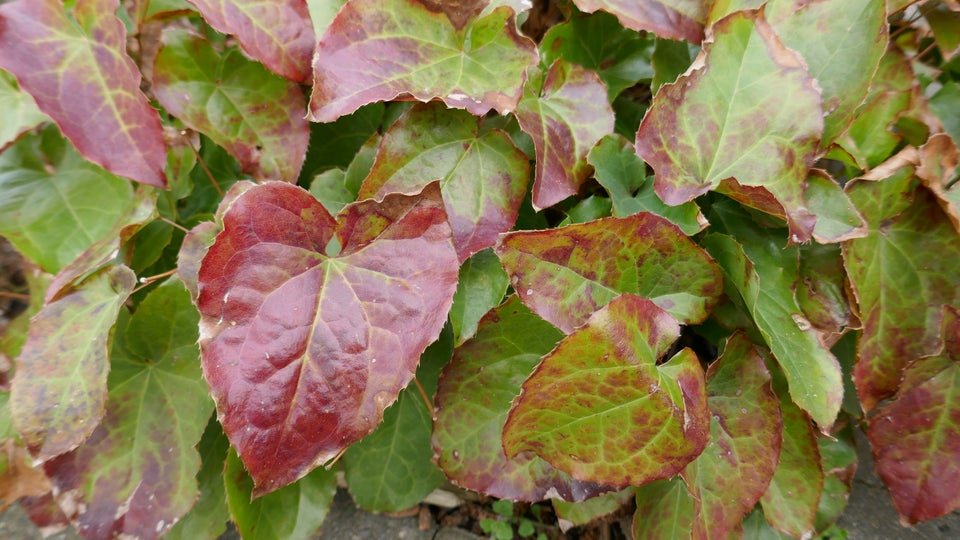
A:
450,249,510,345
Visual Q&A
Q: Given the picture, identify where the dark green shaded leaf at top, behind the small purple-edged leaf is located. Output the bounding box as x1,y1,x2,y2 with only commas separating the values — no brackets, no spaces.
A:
540,12,654,101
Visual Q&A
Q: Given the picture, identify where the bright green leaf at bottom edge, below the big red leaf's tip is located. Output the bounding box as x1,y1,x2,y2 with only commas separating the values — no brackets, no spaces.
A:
223,450,337,540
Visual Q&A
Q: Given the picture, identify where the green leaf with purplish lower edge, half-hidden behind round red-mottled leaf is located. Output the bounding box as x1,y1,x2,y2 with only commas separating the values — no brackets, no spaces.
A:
432,296,607,501
